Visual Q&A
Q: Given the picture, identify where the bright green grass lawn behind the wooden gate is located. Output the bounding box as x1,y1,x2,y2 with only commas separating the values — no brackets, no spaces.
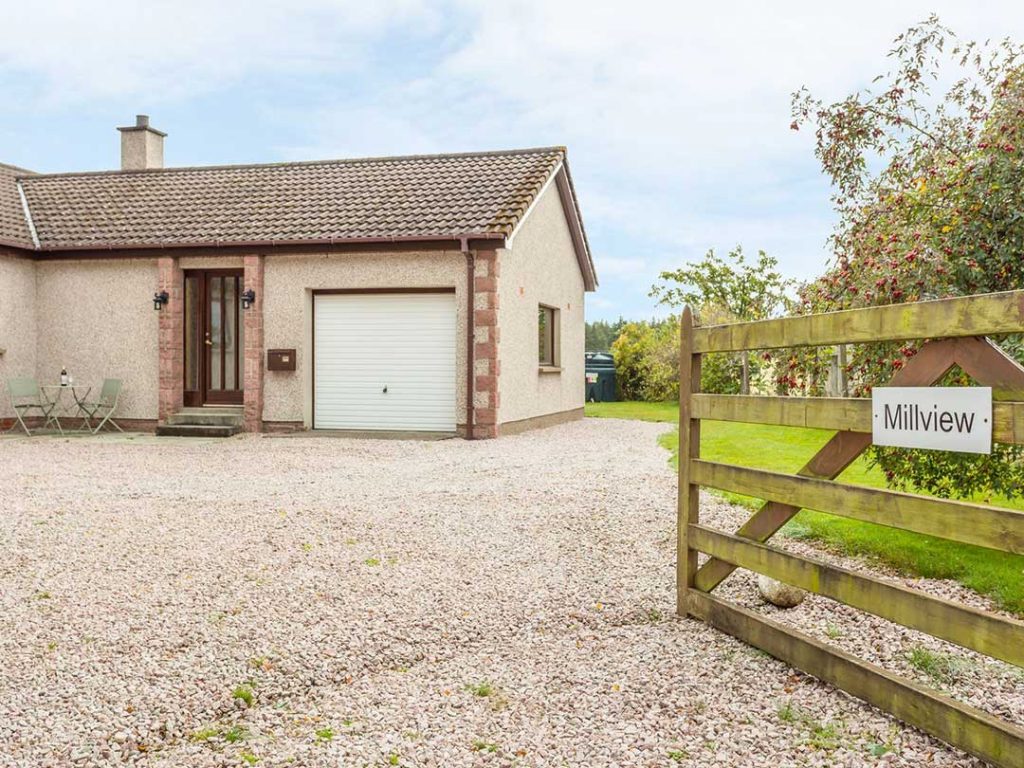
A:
587,402,1024,614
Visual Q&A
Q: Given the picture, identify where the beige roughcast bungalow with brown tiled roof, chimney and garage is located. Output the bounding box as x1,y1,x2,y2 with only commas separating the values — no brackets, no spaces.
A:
0,116,597,437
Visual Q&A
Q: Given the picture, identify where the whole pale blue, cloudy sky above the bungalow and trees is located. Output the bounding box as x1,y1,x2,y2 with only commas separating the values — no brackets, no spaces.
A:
0,0,1024,319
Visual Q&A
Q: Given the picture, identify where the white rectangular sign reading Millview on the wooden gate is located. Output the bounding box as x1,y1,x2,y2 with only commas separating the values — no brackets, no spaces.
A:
871,387,992,454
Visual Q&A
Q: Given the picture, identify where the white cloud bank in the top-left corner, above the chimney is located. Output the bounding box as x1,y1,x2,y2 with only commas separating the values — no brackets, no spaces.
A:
0,0,439,108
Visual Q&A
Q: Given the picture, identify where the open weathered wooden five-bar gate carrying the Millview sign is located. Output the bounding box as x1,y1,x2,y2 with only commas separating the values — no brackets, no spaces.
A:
676,291,1024,768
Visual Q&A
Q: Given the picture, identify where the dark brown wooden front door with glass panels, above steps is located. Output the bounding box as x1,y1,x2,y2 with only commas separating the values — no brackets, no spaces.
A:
184,269,245,406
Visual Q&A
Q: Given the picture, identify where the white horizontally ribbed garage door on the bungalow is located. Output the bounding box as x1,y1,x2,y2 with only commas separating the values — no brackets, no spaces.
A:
313,293,456,432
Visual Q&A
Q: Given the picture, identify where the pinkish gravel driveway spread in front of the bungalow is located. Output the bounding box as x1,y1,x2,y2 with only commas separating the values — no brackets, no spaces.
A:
0,420,991,768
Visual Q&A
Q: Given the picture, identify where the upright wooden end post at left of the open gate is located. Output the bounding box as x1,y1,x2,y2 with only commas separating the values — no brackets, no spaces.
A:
676,306,700,616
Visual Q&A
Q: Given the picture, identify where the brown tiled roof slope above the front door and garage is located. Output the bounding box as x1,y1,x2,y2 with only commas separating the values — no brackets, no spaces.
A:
18,147,574,250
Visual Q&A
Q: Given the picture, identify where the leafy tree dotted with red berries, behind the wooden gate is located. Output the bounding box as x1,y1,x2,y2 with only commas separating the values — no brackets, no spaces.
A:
779,16,1024,497
